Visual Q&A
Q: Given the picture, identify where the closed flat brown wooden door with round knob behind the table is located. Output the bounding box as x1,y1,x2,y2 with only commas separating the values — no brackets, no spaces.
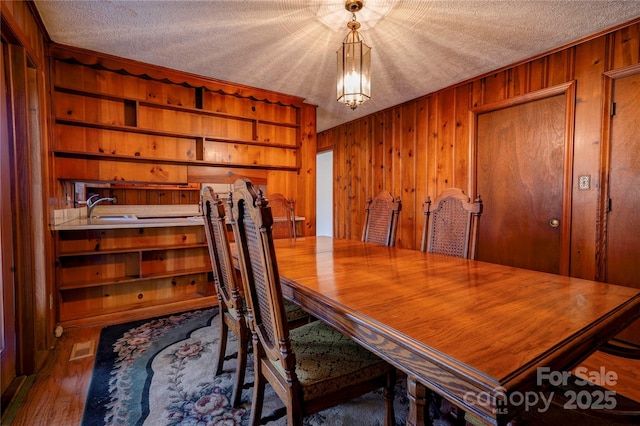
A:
476,94,568,273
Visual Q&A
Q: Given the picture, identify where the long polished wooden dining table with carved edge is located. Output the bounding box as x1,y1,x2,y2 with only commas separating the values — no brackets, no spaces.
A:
275,237,640,425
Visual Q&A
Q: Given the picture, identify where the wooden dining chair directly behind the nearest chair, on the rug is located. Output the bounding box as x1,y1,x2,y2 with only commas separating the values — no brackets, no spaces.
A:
202,186,250,407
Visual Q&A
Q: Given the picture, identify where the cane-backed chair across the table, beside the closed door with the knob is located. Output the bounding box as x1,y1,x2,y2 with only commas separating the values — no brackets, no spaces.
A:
420,188,482,259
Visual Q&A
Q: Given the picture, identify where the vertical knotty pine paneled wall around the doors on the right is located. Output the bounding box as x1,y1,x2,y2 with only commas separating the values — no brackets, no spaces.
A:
317,19,640,278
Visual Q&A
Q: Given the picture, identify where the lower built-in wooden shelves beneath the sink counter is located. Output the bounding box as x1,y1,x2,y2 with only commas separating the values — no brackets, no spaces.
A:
55,225,215,321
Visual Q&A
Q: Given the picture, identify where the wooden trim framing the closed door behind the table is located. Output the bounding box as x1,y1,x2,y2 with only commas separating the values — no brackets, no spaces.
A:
468,80,576,275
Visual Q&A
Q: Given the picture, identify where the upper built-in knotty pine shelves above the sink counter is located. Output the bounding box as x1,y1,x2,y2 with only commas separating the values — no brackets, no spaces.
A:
53,84,301,175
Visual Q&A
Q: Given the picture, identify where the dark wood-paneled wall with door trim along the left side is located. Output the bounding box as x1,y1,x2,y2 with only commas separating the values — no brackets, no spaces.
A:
1,1,55,372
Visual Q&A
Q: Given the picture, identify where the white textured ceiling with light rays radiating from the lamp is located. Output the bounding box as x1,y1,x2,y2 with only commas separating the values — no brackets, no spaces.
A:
35,0,640,131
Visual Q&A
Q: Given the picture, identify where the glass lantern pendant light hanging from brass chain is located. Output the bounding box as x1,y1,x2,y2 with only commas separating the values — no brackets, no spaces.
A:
337,0,371,109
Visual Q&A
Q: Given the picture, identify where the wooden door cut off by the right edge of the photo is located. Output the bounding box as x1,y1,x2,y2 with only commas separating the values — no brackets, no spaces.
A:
605,74,640,345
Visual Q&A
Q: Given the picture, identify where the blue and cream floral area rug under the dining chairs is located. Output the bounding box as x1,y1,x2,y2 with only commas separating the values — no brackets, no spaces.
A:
82,308,408,426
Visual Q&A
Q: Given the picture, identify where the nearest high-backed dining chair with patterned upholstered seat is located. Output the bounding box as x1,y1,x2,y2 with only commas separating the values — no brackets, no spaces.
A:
228,179,395,425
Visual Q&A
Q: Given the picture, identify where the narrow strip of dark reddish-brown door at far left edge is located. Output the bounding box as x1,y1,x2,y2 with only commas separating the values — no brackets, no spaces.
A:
0,43,16,402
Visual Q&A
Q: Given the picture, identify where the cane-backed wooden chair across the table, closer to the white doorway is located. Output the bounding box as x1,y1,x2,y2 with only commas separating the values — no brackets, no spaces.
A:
362,191,402,247
